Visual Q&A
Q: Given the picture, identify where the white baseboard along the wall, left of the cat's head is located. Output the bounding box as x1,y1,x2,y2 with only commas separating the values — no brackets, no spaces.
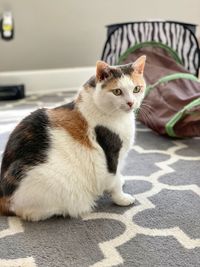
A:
0,67,95,95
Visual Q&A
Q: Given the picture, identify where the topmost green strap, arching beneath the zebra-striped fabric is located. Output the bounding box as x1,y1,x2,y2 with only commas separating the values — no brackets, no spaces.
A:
117,41,184,65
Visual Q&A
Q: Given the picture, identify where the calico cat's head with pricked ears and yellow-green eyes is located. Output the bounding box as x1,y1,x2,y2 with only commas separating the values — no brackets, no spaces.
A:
86,56,146,113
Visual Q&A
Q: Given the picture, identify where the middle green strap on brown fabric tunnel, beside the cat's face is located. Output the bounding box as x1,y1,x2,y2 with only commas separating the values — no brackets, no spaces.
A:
145,72,200,96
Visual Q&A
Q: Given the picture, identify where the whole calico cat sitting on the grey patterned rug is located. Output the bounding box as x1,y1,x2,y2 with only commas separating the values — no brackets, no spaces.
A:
0,56,146,221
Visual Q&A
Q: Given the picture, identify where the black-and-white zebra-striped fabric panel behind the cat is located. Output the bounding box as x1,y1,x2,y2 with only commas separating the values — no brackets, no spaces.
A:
102,21,199,75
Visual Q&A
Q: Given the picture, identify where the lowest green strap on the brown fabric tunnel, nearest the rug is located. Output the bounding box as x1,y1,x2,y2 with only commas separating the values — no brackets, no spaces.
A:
165,97,200,137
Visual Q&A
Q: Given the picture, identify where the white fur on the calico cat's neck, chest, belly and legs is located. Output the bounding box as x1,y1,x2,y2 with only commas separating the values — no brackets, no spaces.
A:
12,75,142,221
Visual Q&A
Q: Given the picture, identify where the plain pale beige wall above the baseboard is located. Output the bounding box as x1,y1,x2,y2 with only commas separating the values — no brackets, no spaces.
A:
0,0,200,71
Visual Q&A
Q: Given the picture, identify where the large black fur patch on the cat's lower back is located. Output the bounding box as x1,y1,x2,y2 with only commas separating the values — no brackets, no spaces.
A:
0,109,50,196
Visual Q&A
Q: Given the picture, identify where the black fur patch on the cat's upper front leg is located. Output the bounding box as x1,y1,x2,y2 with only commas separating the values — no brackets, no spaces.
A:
95,126,122,174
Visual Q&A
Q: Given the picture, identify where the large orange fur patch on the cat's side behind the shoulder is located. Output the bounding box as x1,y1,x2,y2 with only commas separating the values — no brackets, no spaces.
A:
48,108,92,148
